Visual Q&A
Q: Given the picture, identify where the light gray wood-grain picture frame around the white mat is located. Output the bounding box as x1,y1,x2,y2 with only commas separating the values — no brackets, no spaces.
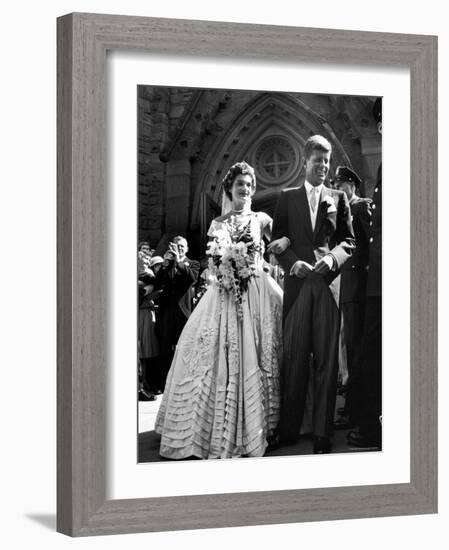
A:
57,13,437,536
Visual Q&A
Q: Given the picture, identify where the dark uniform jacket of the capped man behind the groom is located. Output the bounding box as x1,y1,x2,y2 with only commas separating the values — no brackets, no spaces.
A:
340,197,371,304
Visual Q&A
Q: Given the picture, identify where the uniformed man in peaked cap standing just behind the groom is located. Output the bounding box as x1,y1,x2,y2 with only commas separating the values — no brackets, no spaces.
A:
334,166,371,428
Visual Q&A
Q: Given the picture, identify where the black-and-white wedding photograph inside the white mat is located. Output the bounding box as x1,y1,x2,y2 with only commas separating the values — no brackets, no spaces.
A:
136,85,382,463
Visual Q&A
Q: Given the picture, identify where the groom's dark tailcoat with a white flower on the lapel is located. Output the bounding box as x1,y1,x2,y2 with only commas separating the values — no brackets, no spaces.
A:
273,186,355,316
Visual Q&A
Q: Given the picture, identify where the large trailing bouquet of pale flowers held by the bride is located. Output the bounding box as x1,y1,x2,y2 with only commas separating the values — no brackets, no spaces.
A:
206,216,261,318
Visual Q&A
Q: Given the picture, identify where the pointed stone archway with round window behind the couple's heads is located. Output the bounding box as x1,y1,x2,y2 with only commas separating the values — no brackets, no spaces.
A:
191,92,351,229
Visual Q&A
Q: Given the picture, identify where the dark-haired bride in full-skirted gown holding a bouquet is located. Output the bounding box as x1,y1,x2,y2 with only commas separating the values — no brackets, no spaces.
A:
155,162,282,459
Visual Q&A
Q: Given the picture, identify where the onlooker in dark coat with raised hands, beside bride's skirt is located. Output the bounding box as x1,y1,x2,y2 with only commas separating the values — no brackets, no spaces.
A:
156,236,200,390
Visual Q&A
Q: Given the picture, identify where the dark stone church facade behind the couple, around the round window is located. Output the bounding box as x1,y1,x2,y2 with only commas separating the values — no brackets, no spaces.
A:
138,86,381,256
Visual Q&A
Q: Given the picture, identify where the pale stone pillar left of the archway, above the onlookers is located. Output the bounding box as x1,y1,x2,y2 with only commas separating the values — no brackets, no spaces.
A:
165,159,191,235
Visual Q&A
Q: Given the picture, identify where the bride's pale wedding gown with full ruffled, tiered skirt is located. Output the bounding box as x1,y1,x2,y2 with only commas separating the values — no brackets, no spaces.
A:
155,213,282,459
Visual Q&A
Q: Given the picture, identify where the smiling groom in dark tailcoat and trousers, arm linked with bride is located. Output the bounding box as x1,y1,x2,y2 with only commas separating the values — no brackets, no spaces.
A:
273,135,355,454
